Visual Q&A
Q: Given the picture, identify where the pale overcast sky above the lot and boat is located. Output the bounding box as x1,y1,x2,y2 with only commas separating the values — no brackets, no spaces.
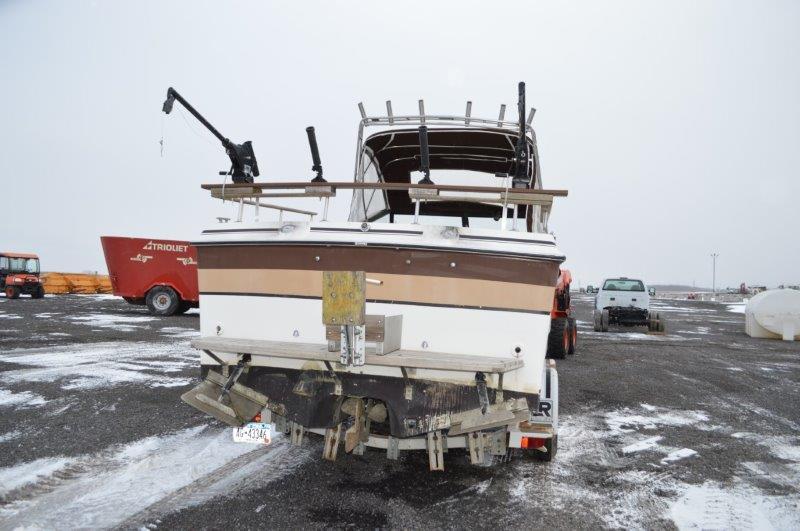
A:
0,0,800,286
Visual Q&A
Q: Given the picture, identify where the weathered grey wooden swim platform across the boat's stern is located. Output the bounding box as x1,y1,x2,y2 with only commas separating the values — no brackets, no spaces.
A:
192,337,524,374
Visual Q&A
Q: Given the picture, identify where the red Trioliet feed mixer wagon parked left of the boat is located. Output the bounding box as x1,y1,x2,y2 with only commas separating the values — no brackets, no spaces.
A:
100,236,199,315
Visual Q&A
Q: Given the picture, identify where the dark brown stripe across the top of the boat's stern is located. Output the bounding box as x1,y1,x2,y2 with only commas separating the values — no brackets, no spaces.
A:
197,245,559,287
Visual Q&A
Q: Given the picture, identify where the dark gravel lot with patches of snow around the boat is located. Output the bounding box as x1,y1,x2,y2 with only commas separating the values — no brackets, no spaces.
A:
0,295,800,529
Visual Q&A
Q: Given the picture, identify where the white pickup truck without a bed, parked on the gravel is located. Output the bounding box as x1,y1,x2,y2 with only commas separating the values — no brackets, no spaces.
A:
594,277,666,332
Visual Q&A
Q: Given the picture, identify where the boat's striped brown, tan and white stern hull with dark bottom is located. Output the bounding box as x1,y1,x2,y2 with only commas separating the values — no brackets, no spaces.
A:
194,223,563,430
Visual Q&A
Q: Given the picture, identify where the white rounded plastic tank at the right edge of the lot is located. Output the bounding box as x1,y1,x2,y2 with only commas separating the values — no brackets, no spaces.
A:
744,289,800,341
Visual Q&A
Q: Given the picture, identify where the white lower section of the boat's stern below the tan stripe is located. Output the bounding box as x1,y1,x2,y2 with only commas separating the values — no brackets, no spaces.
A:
200,295,550,394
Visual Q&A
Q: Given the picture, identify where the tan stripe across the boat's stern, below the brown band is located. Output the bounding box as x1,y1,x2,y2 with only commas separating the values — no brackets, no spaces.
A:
198,269,553,312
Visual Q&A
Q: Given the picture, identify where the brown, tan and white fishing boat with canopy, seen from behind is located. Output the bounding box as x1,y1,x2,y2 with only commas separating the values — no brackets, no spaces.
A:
170,83,567,470
